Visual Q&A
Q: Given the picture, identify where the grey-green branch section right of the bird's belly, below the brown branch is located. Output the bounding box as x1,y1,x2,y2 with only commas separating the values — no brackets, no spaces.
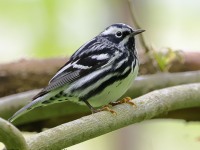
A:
124,71,200,97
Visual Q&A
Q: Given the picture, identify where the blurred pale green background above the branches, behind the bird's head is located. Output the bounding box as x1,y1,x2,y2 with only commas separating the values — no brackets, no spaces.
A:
0,0,200,62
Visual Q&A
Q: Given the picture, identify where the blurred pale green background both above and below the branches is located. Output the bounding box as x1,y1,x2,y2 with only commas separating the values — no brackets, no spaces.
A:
0,0,200,150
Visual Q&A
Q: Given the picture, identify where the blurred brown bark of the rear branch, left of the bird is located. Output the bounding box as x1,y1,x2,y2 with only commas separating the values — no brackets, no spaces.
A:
0,58,67,97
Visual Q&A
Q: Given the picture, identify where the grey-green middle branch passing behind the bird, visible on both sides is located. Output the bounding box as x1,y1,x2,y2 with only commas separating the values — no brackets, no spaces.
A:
0,71,200,127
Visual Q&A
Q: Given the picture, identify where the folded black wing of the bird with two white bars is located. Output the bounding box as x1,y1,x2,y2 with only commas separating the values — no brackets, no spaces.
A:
33,40,111,100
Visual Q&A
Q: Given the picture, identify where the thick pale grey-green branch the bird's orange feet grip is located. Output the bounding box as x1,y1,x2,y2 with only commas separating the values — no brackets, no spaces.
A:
27,83,200,150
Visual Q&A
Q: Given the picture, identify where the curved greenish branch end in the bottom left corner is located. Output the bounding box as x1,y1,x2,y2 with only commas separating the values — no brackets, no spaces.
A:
0,118,28,150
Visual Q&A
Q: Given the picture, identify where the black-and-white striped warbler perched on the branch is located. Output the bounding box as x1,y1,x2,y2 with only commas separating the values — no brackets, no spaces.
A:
9,23,144,121
